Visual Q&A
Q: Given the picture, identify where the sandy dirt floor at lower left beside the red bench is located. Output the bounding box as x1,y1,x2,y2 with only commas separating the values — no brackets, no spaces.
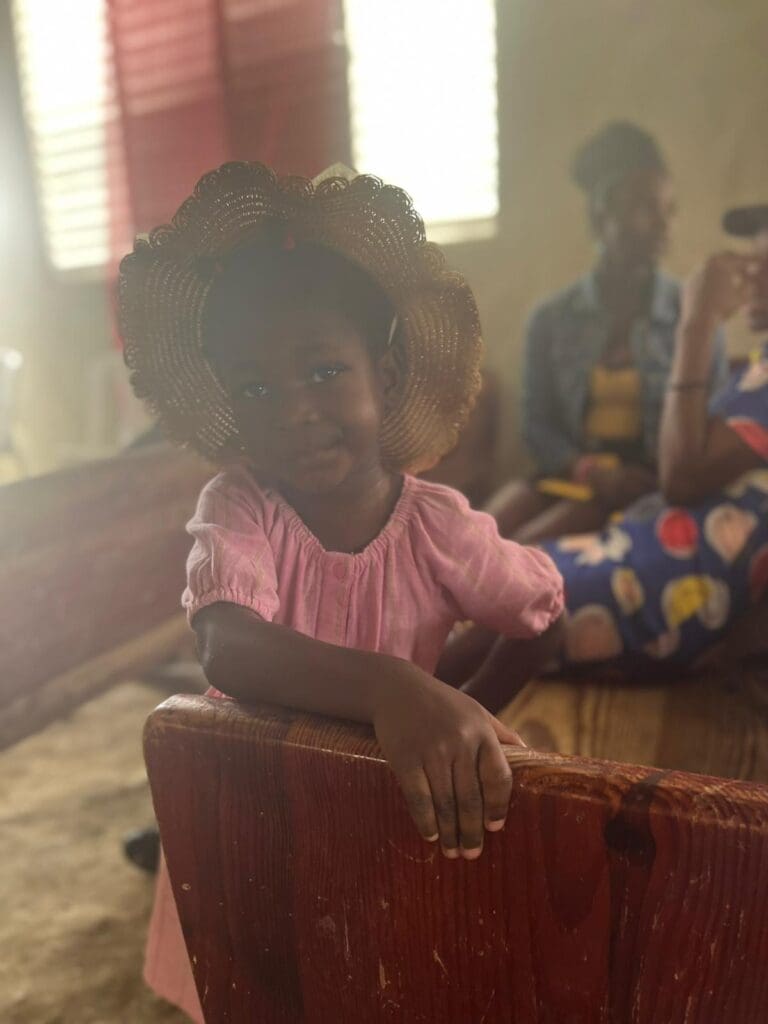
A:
0,683,187,1024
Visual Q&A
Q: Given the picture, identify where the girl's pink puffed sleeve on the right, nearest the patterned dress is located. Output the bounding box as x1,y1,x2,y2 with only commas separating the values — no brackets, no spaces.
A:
421,488,563,639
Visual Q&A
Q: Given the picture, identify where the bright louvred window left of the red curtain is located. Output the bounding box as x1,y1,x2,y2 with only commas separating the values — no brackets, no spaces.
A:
13,0,110,270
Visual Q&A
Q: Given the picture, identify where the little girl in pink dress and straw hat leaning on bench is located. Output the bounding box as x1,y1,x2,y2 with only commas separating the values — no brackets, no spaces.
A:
121,164,562,1021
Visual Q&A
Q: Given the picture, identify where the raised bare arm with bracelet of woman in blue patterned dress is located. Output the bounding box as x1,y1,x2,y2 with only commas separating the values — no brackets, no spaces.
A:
658,253,762,505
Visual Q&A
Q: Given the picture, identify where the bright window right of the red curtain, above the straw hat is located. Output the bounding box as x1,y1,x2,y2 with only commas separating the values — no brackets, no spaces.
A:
344,0,499,242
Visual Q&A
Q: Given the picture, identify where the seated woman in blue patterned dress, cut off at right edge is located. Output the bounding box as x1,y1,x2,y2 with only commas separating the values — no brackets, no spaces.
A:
438,214,768,711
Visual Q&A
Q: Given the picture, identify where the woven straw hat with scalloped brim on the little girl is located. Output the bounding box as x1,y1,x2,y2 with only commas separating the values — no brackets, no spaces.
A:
120,163,481,472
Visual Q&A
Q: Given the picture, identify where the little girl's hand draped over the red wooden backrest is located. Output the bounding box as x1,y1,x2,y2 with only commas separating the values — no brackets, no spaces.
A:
373,666,522,860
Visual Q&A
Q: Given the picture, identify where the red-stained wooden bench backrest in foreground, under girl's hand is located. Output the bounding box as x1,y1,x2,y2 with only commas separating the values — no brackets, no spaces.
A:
144,697,768,1024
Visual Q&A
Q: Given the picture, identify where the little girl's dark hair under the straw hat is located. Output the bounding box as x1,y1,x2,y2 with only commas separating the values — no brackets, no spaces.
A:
203,224,394,358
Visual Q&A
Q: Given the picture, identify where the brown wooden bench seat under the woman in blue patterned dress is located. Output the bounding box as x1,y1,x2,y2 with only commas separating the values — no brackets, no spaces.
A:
500,666,768,782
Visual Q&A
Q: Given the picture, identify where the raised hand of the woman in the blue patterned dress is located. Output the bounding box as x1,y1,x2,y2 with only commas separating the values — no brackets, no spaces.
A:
682,252,760,328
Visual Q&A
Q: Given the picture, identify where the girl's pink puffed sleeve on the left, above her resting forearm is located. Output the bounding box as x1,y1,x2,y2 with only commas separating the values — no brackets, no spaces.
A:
181,473,280,623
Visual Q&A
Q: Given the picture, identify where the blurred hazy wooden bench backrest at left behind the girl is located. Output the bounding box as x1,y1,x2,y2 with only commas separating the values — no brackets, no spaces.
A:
0,444,213,748
